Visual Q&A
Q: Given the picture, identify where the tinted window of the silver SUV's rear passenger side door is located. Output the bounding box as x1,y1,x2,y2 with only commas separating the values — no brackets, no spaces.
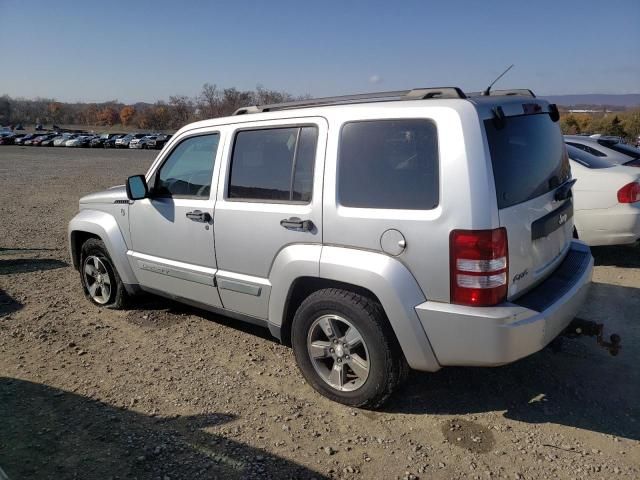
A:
229,127,318,202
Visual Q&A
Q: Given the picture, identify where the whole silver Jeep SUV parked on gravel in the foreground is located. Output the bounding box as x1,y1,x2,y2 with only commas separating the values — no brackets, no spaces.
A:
69,88,593,408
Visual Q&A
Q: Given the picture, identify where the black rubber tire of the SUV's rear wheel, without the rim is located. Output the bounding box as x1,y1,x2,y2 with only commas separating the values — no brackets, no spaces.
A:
291,288,409,409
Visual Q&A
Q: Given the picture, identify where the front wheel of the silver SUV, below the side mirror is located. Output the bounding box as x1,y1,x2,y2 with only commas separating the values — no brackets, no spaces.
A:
80,238,128,309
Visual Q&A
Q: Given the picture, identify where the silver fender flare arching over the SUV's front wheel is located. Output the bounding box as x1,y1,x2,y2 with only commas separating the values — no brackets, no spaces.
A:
68,209,138,285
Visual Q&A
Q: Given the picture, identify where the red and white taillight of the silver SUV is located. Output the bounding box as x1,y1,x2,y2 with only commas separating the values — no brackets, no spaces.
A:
449,228,509,307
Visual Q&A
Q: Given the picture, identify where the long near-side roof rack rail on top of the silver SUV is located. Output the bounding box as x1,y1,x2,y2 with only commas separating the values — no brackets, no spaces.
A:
233,87,467,115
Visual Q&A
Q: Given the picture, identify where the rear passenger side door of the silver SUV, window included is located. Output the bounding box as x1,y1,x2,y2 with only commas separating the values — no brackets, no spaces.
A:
214,117,327,319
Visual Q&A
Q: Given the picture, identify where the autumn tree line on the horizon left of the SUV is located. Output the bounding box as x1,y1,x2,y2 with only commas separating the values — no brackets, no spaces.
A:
0,83,308,130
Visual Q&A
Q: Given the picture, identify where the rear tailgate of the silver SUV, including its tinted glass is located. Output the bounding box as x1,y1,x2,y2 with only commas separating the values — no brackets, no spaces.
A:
484,111,573,299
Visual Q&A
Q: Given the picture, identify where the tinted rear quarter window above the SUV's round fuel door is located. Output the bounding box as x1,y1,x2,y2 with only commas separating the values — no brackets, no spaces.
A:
338,119,439,210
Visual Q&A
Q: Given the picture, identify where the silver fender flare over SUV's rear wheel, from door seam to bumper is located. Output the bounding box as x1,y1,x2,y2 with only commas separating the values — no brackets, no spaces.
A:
320,246,440,372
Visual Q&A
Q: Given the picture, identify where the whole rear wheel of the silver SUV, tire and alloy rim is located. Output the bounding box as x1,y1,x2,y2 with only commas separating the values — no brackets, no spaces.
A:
291,288,408,408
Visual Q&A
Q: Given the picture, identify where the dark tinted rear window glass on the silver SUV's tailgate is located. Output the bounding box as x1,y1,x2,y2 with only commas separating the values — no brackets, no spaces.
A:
484,113,571,208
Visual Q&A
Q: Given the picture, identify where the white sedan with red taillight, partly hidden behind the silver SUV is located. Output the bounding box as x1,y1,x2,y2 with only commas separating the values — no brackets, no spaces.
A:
567,145,640,246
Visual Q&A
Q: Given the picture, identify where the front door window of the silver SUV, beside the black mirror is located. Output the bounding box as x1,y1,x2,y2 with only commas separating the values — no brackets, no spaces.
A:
154,133,220,198
